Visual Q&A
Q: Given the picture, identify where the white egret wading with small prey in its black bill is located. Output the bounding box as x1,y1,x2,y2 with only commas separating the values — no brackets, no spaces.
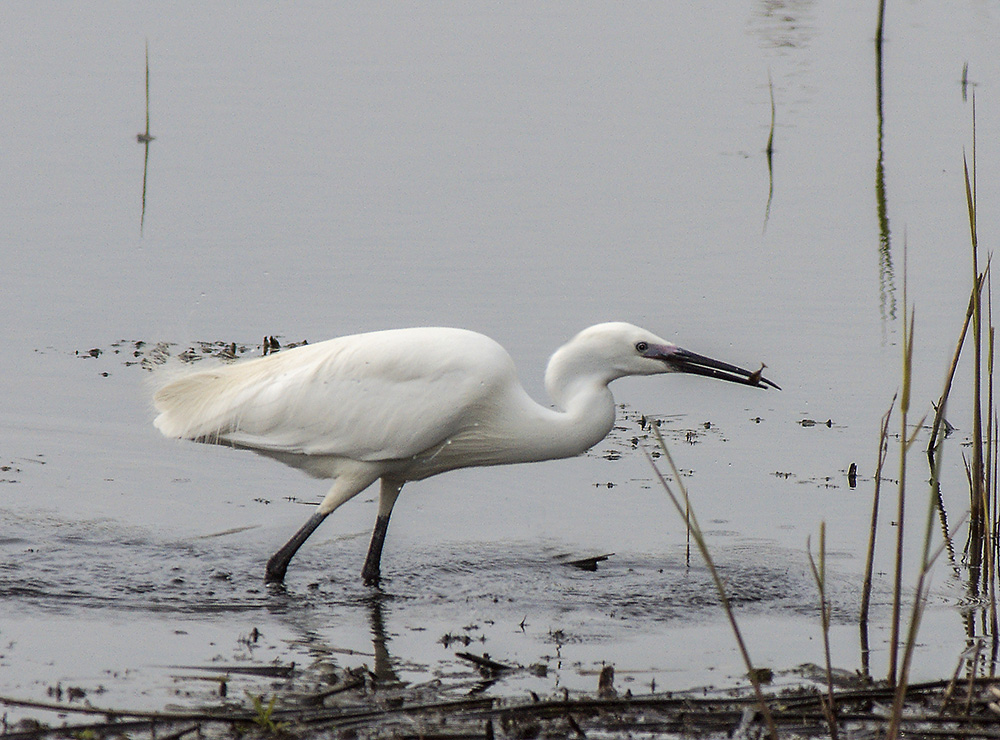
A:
154,323,778,585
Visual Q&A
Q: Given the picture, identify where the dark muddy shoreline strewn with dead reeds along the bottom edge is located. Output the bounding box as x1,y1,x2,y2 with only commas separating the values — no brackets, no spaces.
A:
0,668,1000,740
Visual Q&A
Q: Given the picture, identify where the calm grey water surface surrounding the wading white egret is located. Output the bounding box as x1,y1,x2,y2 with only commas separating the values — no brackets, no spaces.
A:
0,0,1000,707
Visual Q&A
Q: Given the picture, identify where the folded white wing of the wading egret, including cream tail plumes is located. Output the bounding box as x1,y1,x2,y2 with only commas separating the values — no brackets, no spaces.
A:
154,328,515,461
